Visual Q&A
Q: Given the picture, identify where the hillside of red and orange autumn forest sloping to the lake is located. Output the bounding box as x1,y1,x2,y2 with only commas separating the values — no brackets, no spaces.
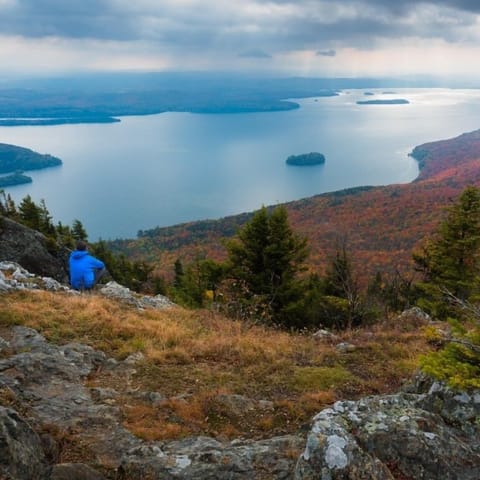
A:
111,131,480,284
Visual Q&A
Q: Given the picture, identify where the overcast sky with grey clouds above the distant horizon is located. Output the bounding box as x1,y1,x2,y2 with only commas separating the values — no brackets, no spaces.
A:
0,0,480,80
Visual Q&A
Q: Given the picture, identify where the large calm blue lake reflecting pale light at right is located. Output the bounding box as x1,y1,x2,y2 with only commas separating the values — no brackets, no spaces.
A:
0,89,480,240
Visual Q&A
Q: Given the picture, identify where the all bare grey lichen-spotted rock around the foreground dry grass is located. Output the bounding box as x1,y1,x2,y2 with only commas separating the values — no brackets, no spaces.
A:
0,262,480,480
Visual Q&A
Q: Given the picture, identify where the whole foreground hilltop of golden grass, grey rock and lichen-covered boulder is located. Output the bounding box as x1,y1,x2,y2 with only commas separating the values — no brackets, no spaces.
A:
0,262,480,480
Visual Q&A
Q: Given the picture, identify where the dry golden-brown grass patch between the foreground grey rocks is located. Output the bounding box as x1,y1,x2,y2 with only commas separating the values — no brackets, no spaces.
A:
0,291,432,440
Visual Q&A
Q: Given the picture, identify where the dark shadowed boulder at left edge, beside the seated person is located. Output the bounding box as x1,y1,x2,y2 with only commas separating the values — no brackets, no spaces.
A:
0,217,68,282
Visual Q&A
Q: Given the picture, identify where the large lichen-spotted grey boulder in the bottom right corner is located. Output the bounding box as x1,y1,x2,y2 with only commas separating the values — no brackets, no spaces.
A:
295,383,480,480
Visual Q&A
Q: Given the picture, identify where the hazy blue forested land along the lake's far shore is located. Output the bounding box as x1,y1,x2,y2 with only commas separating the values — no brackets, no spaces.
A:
0,73,342,126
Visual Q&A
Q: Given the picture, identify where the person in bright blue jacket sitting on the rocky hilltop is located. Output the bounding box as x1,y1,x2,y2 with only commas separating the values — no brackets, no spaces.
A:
68,240,106,290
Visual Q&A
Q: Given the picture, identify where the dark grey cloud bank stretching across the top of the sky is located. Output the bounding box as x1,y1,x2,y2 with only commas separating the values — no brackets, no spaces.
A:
0,0,480,50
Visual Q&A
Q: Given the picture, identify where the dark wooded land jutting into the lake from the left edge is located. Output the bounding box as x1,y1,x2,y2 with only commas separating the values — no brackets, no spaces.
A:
0,143,62,188
